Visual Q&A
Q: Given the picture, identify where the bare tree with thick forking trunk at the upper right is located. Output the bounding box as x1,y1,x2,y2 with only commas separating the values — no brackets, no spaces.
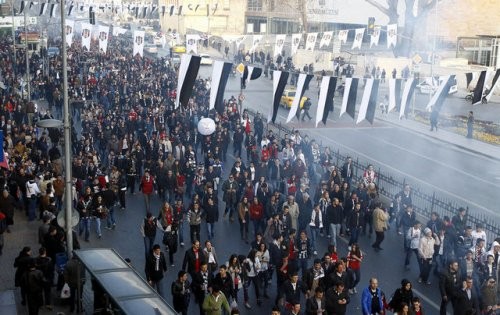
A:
365,0,438,57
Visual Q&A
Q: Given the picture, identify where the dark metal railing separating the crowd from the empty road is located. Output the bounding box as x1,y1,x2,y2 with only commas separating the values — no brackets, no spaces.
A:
247,109,500,242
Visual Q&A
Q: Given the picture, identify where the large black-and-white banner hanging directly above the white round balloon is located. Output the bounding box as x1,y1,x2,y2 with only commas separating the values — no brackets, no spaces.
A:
209,60,233,115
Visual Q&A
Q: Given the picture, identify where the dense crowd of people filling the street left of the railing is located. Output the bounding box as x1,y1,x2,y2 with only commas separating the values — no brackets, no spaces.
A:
0,31,500,315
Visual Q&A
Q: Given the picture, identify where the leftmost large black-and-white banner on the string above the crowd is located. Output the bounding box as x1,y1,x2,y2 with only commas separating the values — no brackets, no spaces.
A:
175,54,201,109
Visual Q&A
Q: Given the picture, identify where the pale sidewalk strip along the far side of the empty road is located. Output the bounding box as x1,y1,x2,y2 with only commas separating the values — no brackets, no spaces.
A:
376,113,500,161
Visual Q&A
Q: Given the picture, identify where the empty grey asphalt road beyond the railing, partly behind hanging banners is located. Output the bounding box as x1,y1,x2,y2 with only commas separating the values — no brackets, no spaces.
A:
213,68,500,225
